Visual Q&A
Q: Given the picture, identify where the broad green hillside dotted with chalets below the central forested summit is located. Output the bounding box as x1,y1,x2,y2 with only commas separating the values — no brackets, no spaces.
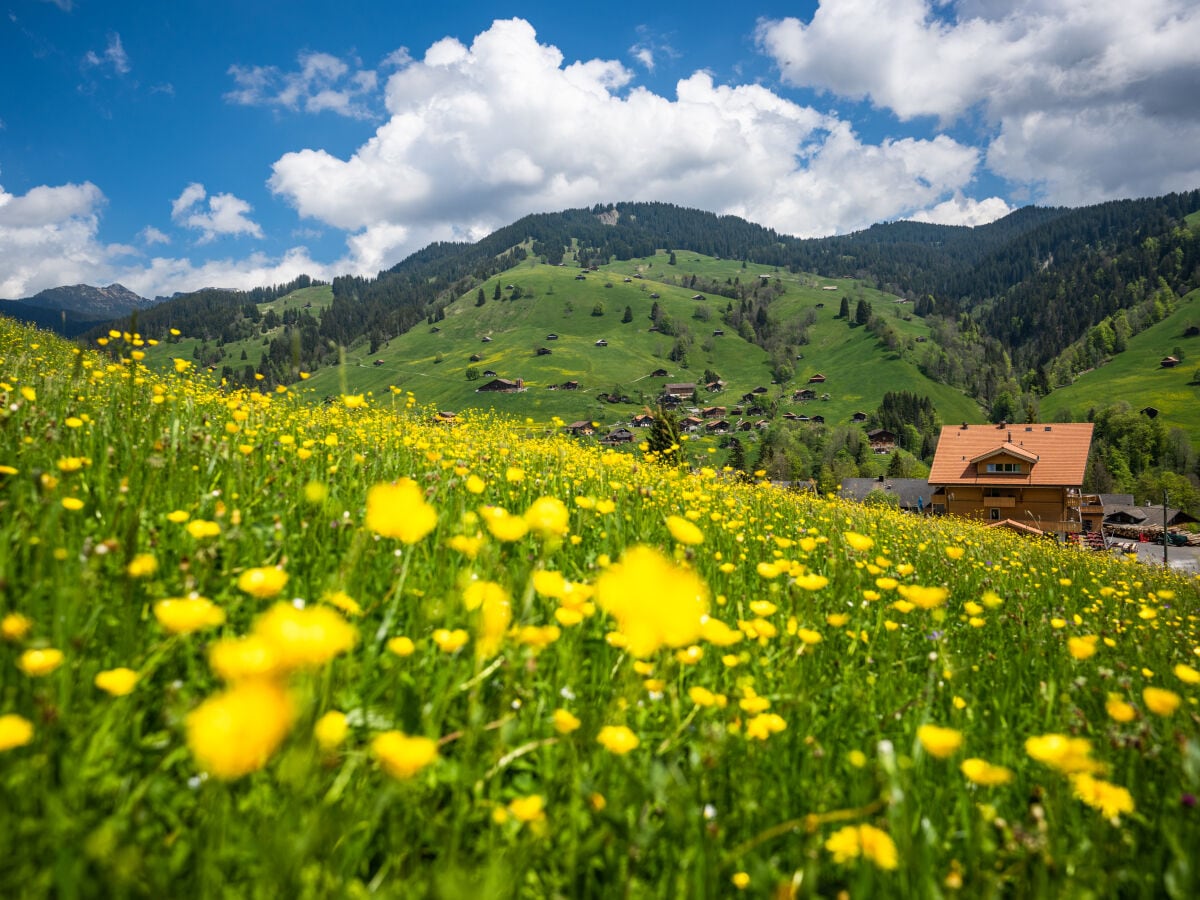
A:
295,252,979,424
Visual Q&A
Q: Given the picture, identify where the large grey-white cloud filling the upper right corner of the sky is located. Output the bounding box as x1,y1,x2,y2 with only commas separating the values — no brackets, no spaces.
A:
757,0,1200,204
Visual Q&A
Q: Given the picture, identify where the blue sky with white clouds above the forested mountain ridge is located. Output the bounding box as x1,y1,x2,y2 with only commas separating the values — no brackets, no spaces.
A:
0,0,1200,299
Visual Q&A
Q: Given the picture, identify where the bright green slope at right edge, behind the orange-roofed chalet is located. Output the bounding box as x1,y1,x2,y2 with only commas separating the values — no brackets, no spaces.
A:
1042,290,1200,440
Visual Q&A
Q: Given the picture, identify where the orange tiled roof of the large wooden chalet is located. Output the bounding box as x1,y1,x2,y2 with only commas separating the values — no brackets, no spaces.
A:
929,422,1094,487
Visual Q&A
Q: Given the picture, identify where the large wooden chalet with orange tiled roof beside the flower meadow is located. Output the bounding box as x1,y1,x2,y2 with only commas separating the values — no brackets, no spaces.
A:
929,422,1094,535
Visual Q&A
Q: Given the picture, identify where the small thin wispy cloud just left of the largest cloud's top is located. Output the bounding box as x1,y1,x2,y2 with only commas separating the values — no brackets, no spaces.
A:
224,50,376,119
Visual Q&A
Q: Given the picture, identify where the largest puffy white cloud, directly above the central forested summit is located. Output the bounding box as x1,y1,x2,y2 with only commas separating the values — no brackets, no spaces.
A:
269,19,998,271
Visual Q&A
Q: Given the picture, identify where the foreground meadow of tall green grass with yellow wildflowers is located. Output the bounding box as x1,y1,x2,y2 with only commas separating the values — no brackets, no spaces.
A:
0,323,1200,898
